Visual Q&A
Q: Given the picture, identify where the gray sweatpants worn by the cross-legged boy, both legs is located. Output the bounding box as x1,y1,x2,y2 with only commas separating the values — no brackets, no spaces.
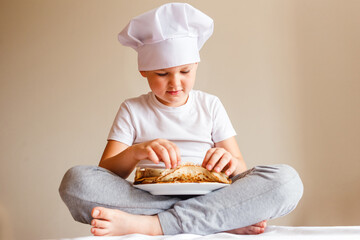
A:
59,165,303,235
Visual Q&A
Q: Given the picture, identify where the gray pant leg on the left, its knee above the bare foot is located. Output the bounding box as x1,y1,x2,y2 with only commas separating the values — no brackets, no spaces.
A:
59,166,181,224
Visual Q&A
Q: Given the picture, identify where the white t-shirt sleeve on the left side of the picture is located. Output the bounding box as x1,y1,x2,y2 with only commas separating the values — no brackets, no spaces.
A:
108,102,135,146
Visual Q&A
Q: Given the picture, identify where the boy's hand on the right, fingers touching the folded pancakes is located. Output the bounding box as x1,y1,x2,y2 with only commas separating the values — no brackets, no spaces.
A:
202,148,238,176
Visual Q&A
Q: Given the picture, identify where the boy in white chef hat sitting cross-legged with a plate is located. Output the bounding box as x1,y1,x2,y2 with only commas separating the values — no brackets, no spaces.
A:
60,3,303,236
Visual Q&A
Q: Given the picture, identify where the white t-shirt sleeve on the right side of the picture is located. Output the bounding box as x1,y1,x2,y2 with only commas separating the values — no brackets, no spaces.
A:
212,98,236,143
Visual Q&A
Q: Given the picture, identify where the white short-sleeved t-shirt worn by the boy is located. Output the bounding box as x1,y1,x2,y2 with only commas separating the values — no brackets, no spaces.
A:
108,90,236,167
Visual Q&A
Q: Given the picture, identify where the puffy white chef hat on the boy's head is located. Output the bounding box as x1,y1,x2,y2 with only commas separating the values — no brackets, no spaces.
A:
118,3,214,71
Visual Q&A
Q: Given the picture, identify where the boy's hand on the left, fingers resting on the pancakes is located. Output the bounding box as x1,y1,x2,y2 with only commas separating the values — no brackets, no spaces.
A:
134,139,181,168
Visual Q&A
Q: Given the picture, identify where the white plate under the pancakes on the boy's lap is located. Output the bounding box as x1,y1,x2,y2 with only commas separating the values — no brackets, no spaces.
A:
133,183,230,195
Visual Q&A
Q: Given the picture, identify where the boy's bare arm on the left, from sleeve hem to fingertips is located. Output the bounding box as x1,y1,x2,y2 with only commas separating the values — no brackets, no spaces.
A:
99,139,180,179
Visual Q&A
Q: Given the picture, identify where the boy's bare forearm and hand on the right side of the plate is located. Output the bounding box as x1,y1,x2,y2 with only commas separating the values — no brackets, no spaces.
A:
202,137,246,176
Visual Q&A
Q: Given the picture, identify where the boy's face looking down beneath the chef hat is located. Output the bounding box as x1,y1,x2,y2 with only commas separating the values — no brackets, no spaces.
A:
140,63,198,107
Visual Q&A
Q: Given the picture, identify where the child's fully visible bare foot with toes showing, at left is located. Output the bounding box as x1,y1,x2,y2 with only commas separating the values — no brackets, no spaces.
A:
91,207,163,236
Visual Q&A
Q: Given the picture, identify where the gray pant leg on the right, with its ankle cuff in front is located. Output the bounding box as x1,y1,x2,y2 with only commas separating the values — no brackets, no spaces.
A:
158,165,303,234
